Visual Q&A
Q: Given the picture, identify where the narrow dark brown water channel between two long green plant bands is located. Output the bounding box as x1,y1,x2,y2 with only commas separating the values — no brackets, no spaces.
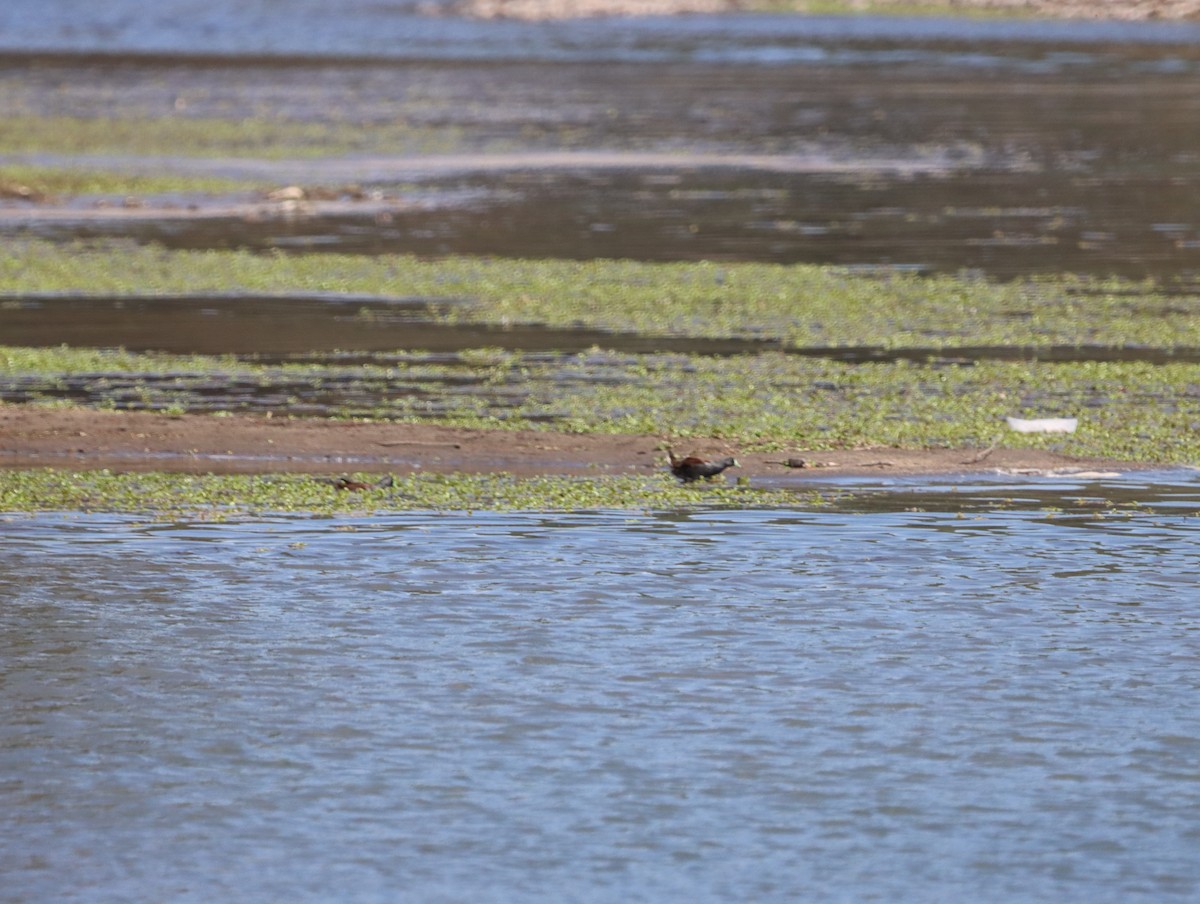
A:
9,285,1200,364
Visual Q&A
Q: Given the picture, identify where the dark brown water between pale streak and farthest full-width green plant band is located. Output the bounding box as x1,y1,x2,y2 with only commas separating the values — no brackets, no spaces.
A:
28,160,1200,279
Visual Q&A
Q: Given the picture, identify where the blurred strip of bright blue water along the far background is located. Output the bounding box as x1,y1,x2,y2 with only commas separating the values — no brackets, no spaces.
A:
0,0,1200,64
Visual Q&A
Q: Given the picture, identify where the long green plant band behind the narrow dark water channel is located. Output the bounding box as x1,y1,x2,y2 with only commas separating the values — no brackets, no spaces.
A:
0,240,1200,348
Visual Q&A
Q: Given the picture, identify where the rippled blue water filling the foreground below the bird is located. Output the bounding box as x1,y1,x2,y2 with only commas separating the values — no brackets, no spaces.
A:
0,474,1200,903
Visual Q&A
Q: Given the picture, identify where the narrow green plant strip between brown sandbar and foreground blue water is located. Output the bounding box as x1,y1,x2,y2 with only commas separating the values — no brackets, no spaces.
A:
0,469,823,520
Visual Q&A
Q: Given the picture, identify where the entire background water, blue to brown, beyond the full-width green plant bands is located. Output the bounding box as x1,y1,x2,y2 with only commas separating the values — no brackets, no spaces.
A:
0,12,1200,276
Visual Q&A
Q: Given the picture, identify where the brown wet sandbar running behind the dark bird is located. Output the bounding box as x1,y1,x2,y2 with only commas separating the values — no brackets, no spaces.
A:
0,406,1153,480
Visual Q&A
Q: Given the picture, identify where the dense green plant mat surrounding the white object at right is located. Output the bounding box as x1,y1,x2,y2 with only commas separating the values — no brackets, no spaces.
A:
540,354,1200,463
